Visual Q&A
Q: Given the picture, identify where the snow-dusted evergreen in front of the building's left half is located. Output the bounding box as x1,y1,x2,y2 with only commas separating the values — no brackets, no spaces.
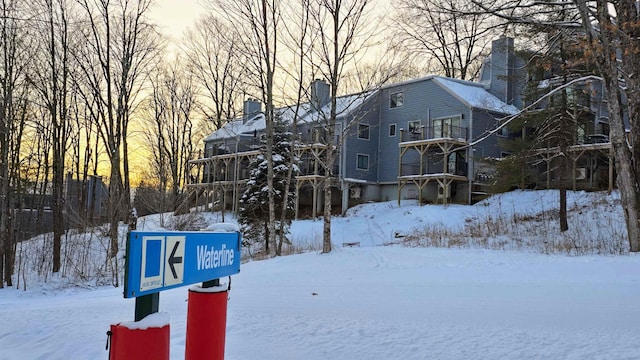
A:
238,117,299,254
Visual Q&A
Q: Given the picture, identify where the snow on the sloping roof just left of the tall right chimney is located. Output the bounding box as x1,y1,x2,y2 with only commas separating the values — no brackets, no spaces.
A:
433,76,518,114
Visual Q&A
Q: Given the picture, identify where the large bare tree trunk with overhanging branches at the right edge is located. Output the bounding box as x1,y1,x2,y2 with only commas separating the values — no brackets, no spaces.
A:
472,0,640,252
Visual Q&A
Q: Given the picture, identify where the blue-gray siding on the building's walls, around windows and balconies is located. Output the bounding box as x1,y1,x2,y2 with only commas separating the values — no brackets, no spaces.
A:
206,77,516,201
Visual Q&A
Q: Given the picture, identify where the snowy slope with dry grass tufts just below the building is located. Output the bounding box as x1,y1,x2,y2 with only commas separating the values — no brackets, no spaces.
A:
292,191,628,254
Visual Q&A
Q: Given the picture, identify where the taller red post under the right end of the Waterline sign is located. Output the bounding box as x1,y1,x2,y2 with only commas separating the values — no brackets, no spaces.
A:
184,284,229,360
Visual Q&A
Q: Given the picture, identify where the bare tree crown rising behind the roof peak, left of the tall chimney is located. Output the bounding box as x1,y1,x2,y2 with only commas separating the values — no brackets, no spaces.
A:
390,0,499,80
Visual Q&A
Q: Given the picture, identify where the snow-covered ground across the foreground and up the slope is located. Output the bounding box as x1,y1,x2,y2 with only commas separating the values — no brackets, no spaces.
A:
0,191,640,360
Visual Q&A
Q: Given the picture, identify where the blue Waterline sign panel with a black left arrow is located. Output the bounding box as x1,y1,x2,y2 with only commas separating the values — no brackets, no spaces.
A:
124,231,242,298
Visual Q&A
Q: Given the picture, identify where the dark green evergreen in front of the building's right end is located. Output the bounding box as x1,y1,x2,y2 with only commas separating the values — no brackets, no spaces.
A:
498,30,593,231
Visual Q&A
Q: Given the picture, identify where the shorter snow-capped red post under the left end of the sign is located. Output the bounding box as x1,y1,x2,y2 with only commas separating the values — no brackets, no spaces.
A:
109,313,170,360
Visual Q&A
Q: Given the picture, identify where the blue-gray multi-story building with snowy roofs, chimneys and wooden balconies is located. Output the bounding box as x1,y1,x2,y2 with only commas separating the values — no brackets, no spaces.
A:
187,37,616,216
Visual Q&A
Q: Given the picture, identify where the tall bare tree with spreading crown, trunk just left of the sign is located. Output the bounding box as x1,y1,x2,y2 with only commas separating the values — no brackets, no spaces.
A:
76,0,159,286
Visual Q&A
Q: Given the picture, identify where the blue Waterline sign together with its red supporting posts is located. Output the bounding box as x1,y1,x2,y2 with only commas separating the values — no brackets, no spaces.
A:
110,229,242,359
